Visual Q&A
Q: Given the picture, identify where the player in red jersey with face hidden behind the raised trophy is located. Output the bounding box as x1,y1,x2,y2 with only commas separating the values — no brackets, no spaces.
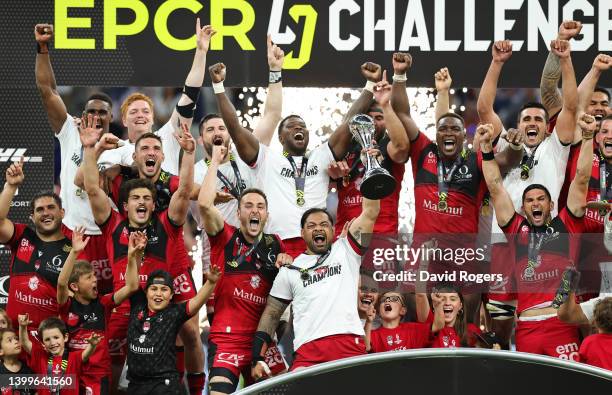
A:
336,53,412,236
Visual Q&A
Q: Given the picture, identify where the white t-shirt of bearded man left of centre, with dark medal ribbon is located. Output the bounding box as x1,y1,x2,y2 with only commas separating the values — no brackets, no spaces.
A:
191,147,256,229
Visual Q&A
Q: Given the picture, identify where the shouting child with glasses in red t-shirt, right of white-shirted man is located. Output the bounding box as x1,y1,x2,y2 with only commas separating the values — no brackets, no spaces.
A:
364,291,444,352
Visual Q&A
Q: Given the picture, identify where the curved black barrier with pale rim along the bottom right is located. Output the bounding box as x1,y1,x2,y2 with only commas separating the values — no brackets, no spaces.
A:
238,348,612,395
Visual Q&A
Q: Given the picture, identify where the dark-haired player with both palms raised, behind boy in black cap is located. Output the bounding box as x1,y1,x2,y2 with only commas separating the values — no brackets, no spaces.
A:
81,117,204,393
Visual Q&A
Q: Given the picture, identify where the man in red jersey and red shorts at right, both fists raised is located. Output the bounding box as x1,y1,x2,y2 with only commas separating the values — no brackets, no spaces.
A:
477,114,596,360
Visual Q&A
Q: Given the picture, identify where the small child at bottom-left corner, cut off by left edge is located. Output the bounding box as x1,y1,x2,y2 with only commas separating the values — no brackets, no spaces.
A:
0,328,35,395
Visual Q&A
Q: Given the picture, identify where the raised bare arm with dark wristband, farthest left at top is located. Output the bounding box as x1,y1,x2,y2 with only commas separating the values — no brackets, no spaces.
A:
34,23,68,134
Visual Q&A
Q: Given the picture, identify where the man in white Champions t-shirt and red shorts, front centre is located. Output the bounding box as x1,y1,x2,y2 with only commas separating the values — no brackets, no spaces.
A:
251,197,380,380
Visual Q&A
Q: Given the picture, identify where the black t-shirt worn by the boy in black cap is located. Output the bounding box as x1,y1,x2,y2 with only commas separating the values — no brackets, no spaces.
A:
127,290,191,383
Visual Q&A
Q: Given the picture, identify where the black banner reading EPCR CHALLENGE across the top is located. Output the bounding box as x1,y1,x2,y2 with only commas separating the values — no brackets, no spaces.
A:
5,0,612,87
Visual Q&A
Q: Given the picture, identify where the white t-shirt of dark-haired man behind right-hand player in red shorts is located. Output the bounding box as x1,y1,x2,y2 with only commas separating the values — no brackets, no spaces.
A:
491,129,570,243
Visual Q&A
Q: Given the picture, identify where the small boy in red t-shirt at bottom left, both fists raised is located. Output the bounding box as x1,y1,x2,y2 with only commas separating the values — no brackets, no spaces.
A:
17,314,100,395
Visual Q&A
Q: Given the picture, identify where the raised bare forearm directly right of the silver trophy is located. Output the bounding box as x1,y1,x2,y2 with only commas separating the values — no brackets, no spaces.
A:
374,71,410,163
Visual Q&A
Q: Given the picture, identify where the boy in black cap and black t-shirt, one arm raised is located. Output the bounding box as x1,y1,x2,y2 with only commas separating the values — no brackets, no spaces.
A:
127,266,221,395
